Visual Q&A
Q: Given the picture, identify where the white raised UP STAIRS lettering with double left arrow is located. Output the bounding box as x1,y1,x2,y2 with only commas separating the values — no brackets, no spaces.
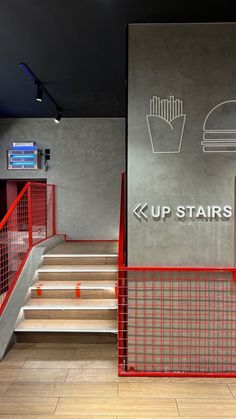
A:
133,203,233,221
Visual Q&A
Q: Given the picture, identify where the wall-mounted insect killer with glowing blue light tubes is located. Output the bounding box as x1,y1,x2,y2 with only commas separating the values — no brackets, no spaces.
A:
7,142,40,170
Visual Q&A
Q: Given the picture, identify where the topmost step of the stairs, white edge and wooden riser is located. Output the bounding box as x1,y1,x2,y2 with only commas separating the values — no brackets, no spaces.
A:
43,254,118,265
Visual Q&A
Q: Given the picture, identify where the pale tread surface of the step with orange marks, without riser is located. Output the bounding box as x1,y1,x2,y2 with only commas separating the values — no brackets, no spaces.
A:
30,281,116,290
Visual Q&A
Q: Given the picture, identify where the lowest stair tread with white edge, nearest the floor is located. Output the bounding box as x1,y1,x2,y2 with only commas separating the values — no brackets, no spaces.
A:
15,319,117,333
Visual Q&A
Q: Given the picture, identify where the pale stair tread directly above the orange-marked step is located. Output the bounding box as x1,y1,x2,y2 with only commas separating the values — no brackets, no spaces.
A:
37,265,118,273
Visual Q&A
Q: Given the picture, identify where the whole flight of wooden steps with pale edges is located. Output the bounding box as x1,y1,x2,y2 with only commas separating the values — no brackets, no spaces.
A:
15,242,118,335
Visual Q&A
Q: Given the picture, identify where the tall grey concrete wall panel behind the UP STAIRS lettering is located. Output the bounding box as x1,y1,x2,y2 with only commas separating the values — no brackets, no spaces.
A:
128,24,236,266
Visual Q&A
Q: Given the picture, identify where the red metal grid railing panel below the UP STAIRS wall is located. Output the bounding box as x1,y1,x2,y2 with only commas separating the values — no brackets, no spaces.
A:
118,267,236,376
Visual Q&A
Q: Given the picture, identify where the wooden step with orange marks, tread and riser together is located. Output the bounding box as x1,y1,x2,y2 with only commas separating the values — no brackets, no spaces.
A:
30,281,116,299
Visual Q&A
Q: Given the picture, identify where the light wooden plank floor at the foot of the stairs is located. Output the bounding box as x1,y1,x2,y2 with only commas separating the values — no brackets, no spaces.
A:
0,342,236,419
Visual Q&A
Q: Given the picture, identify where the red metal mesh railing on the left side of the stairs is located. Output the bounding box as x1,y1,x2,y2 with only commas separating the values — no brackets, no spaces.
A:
0,182,55,314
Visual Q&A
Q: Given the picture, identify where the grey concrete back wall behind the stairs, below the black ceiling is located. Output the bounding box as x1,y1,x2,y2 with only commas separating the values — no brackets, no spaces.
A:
0,118,125,239
